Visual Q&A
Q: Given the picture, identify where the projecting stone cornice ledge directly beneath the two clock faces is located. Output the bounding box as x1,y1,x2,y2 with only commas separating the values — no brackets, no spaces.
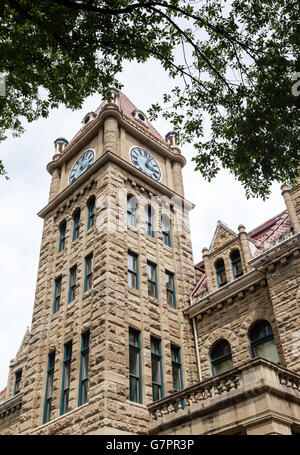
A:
38,151,195,218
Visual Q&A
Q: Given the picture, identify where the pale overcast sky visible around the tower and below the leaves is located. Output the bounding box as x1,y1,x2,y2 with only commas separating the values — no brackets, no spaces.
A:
0,58,285,391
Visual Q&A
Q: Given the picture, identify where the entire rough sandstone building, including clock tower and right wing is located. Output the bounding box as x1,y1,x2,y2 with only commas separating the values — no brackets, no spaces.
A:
0,90,300,435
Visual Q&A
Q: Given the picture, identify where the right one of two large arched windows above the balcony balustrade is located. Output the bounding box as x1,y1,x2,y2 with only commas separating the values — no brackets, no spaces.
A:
249,320,279,363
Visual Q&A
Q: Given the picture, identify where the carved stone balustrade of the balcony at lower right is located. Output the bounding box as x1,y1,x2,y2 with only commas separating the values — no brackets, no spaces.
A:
148,357,300,432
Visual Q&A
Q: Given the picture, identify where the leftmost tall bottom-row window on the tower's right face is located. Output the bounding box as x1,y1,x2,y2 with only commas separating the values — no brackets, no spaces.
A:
129,329,142,403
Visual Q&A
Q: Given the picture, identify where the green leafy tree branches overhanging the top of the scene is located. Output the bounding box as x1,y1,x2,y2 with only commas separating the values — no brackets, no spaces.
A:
0,0,300,198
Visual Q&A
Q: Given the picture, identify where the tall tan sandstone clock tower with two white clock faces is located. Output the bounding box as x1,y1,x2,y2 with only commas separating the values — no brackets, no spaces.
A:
7,90,197,434
